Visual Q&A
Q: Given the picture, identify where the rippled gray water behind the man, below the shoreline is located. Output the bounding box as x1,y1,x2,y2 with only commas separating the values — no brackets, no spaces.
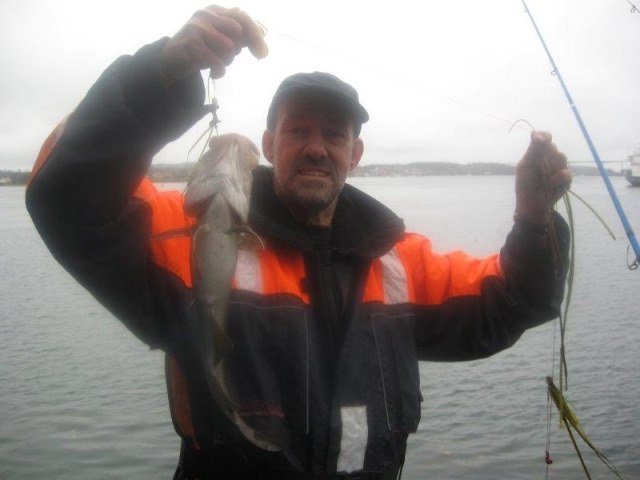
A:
0,177,640,480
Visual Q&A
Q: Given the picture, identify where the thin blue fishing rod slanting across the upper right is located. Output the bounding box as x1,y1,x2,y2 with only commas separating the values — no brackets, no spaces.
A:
521,0,640,270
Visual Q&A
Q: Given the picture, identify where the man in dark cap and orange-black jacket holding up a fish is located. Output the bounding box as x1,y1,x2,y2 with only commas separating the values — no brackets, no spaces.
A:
27,6,571,479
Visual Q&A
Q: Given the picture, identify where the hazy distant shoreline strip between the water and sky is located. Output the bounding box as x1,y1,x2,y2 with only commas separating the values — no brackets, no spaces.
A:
0,162,622,187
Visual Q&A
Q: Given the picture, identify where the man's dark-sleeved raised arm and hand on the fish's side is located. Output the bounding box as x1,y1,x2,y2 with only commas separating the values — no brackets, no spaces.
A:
26,6,266,347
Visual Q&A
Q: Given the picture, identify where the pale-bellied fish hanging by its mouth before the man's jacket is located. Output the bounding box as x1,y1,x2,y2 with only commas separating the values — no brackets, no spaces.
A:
184,134,288,451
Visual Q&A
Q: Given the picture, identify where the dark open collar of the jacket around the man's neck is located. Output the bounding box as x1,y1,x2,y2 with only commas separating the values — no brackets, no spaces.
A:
249,166,404,258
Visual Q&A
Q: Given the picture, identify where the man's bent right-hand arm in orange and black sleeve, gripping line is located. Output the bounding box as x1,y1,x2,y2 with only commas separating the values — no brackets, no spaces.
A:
412,132,571,361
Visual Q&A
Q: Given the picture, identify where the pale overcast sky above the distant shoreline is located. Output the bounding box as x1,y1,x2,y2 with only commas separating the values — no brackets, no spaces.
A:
0,0,640,170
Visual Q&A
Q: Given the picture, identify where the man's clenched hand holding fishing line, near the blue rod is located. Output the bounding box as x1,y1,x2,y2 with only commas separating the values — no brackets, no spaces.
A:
516,131,572,226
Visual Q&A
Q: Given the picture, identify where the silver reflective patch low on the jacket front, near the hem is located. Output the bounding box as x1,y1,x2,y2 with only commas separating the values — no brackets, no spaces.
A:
338,406,369,472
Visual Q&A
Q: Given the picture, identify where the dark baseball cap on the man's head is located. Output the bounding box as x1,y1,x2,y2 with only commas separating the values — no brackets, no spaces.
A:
267,72,369,136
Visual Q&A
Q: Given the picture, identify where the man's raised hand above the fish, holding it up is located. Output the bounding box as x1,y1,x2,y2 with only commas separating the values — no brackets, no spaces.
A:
160,5,269,86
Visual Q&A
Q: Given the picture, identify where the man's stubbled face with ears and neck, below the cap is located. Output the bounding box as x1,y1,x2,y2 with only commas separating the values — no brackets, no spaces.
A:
262,93,363,219
